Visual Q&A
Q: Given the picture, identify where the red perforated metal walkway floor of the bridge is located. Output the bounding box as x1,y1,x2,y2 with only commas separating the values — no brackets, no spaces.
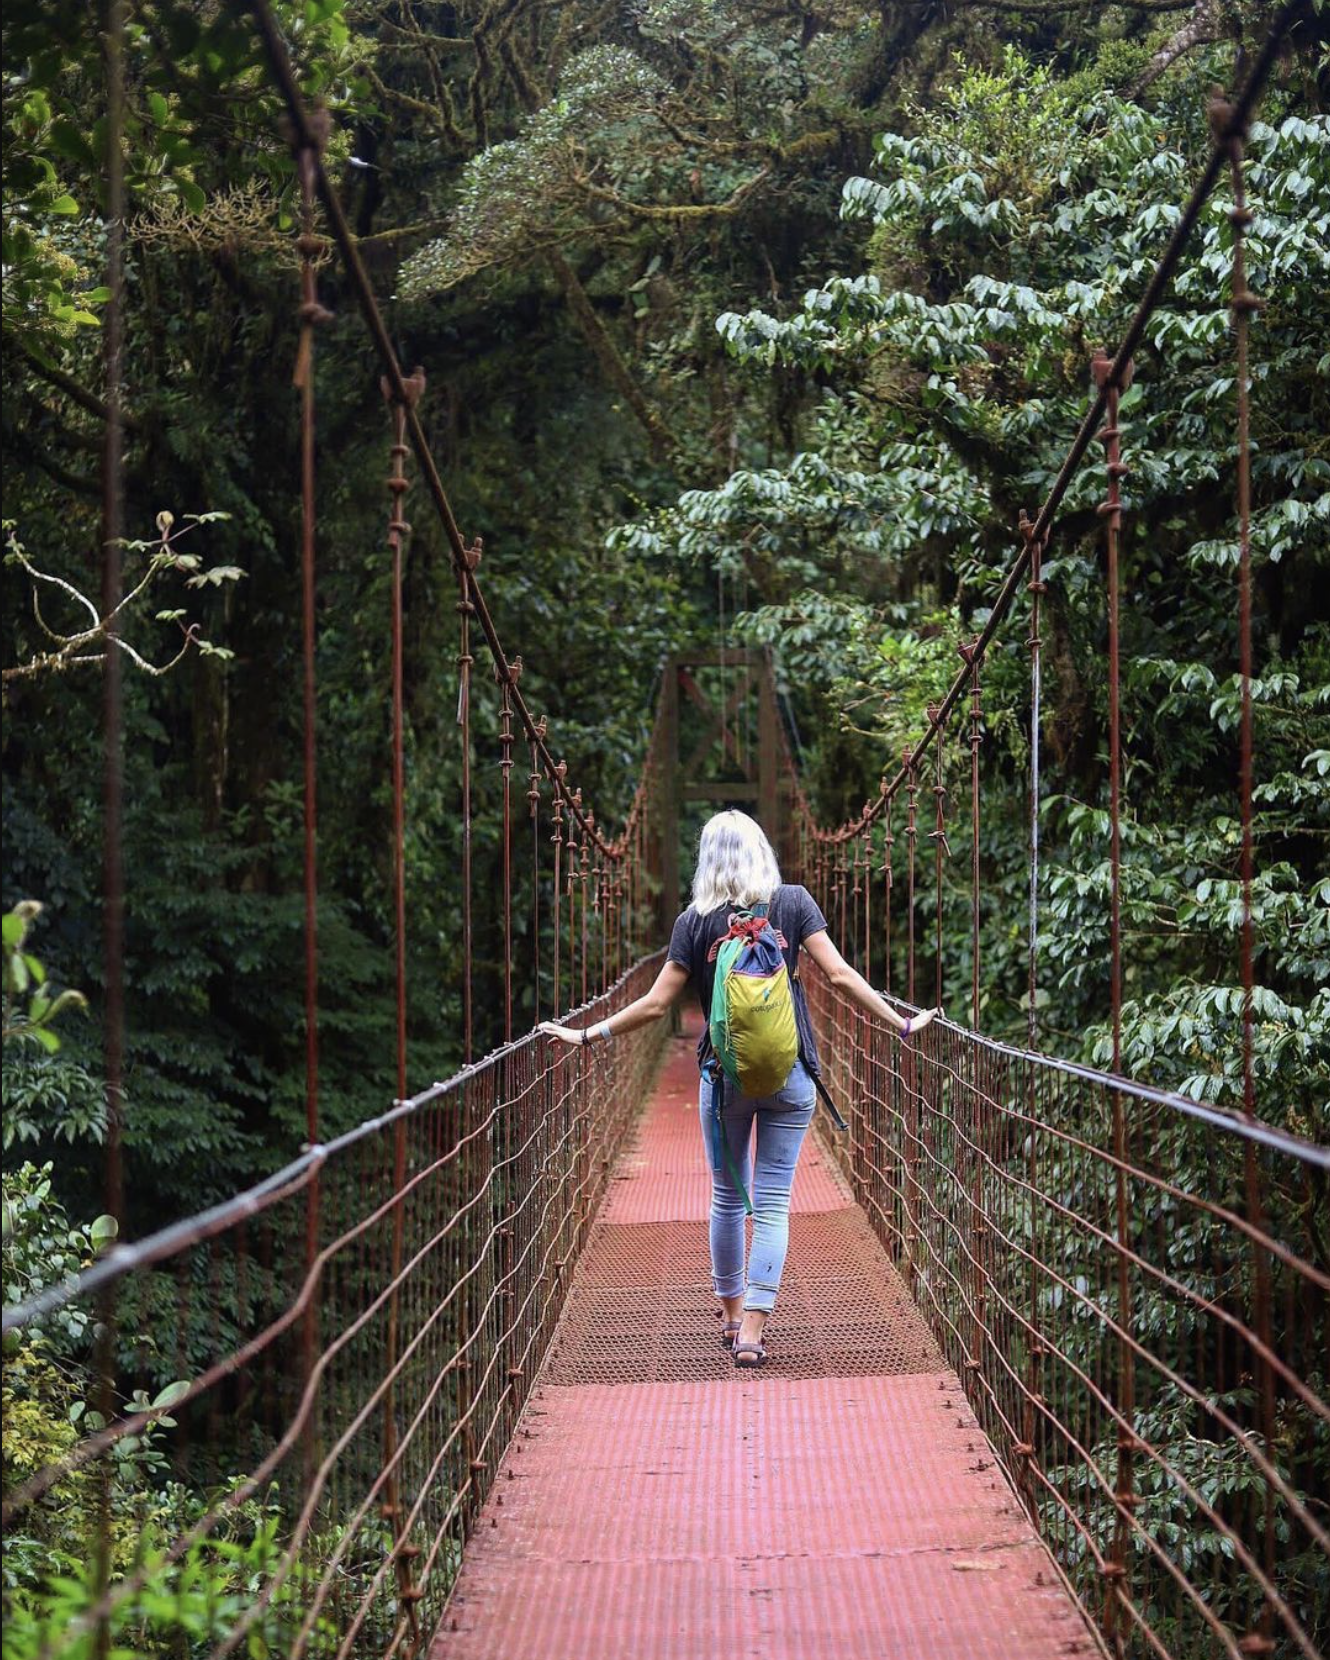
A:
432,1036,1101,1660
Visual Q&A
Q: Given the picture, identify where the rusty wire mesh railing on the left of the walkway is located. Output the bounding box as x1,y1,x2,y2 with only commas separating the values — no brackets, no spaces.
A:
5,958,663,1657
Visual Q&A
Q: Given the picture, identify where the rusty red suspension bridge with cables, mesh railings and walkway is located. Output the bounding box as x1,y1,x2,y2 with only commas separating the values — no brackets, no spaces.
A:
3,0,1330,1660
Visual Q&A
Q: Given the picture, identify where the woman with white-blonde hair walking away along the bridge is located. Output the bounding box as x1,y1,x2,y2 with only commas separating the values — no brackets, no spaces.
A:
540,812,938,1368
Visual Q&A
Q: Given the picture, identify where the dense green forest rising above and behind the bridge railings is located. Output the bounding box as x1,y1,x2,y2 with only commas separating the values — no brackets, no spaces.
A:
3,0,1330,1248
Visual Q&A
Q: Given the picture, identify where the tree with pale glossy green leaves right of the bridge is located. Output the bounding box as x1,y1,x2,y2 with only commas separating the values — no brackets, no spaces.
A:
614,48,1330,1129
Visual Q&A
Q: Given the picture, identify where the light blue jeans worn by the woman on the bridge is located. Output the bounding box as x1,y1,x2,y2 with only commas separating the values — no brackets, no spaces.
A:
699,1061,817,1315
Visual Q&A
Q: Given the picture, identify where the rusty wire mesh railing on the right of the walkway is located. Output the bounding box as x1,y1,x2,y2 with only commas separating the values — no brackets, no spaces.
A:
807,973,1330,1660
